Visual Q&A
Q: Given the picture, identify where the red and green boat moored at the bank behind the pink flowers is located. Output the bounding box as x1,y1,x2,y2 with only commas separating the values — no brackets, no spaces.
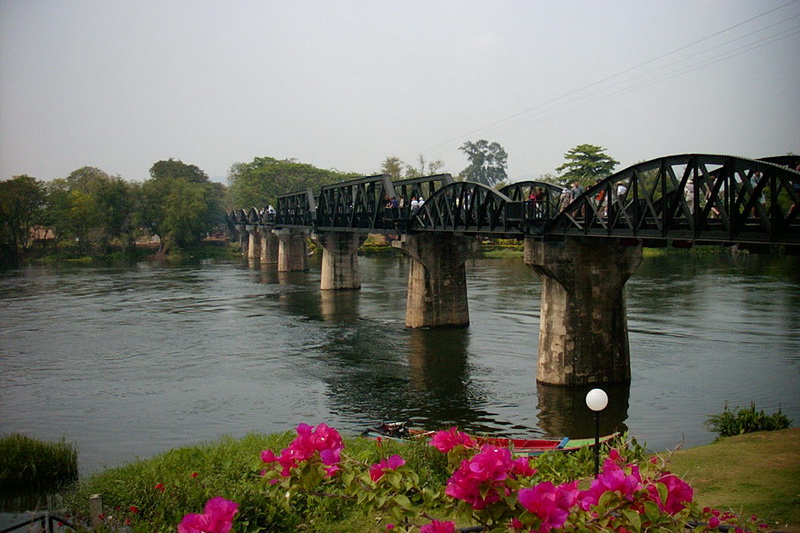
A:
362,422,619,455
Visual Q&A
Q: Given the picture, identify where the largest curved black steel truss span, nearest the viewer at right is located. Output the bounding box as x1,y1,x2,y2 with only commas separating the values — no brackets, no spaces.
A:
545,154,800,245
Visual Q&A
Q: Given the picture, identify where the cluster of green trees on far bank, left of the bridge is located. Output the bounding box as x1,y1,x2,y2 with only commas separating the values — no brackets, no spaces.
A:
0,159,230,264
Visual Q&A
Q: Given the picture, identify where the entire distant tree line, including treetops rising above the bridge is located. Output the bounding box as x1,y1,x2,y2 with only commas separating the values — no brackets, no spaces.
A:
0,140,617,264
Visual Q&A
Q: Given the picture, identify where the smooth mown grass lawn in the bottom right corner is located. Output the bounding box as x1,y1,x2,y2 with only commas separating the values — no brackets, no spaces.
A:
669,428,800,533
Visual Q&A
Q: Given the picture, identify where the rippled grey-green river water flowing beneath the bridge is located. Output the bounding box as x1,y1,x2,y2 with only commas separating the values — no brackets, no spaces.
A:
0,253,800,475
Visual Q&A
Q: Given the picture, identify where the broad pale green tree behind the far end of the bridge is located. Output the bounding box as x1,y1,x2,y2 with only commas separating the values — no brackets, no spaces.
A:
228,157,359,208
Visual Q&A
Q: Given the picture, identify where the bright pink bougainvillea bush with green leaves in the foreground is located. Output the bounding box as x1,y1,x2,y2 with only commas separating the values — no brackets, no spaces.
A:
178,424,759,533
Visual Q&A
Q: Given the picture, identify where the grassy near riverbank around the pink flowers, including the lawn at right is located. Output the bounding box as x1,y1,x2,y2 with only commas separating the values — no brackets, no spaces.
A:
39,428,800,533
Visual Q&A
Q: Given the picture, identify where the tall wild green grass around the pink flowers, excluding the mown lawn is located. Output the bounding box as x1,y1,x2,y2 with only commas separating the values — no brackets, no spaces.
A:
65,433,644,533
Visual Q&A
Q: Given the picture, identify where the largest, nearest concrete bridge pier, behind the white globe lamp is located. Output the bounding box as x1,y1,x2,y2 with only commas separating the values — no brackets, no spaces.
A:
525,238,642,386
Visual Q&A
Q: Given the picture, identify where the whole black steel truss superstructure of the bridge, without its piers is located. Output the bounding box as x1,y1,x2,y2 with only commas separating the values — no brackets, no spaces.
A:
228,154,800,253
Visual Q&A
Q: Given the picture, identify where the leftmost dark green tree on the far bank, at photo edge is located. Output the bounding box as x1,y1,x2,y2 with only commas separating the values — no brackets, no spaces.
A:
0,175,47,264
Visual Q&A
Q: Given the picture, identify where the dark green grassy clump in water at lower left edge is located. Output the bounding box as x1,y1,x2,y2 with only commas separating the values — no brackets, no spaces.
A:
0,433,78,491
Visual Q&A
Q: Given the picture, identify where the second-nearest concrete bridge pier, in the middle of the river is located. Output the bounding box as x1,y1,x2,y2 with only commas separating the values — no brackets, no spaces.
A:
392,234,477,328
